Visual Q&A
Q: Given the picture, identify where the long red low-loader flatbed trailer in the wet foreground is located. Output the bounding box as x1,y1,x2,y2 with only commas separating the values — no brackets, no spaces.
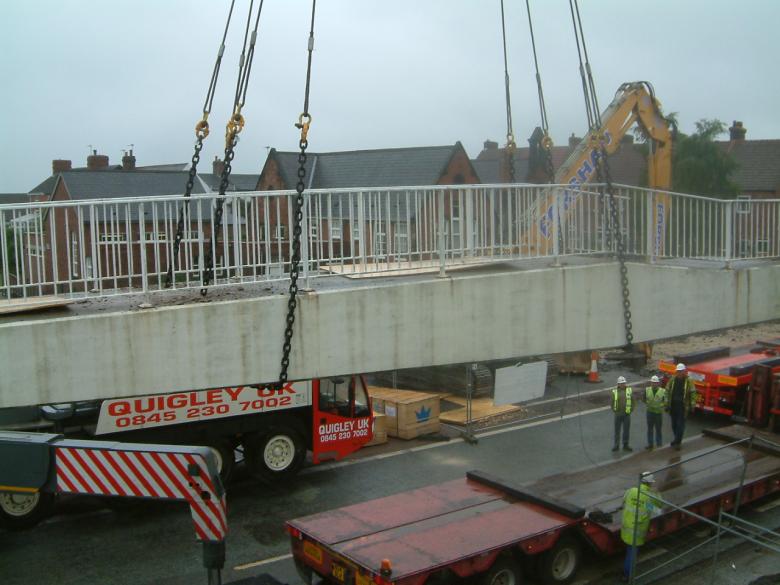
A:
287,426,780,585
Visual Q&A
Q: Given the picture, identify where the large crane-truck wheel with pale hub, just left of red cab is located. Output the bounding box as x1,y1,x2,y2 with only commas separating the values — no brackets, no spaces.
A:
244,425,306,483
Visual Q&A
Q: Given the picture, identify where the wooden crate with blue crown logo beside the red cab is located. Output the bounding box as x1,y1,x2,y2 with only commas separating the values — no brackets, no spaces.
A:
368,386,441,439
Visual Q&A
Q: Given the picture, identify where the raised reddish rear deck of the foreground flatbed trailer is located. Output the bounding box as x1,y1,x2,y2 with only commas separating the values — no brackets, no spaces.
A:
290,479,577,580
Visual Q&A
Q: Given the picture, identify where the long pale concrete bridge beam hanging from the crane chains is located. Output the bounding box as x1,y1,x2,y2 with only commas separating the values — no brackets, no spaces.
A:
0,263,780,407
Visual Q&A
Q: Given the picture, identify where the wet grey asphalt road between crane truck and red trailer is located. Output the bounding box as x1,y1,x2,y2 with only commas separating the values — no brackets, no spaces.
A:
0,394,723,585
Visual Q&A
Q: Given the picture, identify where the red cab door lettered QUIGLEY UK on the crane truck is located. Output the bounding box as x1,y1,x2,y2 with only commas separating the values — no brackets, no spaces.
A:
312,376,373,463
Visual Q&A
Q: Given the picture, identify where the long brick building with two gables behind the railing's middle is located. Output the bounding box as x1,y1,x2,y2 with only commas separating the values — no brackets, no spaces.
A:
257,142,481,262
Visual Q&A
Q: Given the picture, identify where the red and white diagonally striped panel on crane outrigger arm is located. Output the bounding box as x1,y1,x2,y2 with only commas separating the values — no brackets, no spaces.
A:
55,447,227,541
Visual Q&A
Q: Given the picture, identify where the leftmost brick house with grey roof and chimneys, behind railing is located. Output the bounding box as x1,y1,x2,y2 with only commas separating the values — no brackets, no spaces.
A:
18,151,258,294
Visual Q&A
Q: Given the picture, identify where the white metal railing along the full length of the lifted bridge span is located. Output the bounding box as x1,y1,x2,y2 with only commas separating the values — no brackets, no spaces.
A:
0,185,780,298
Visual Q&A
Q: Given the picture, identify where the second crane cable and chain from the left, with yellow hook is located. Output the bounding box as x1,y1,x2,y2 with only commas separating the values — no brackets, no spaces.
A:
200,0,264,296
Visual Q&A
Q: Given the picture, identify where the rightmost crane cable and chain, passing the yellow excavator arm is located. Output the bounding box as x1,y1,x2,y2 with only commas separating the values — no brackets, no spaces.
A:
569,0,634,347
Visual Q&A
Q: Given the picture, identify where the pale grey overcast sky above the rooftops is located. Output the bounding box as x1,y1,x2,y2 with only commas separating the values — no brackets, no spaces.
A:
0,0,780,193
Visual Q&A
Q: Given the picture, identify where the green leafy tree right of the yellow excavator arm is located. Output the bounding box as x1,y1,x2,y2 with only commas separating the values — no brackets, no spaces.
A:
672,119,740,198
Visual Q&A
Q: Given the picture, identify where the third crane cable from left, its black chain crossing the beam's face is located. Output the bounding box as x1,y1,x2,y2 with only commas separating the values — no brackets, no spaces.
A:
278,0,317,387
